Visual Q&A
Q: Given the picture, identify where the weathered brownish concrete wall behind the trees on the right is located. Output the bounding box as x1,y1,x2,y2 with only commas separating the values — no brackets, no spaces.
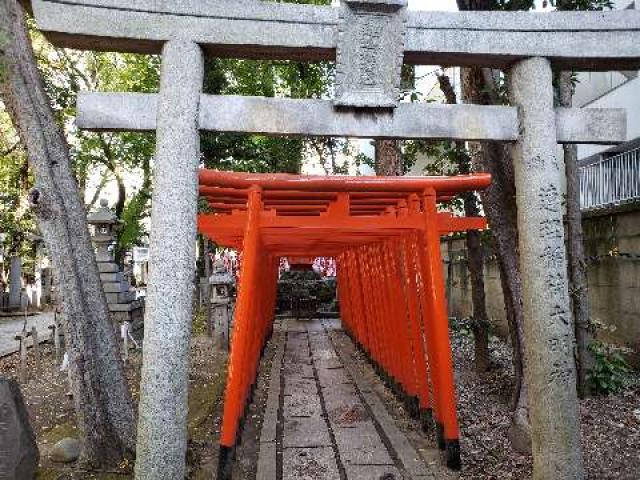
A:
443,206,640,365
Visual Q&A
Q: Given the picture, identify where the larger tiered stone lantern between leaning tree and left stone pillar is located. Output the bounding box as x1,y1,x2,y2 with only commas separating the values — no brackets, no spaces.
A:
87,199,143,324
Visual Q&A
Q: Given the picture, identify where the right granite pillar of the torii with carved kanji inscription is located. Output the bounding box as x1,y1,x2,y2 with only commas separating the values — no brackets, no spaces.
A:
509,58,584,480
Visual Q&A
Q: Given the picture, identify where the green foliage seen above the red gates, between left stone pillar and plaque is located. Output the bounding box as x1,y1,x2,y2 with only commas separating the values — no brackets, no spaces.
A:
201,0,352,173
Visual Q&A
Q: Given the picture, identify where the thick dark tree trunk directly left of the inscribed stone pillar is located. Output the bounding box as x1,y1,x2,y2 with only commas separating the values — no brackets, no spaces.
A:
462,68,531,452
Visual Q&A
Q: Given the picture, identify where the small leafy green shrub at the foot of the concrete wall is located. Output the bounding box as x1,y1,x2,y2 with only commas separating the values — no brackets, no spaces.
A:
587,341,630,395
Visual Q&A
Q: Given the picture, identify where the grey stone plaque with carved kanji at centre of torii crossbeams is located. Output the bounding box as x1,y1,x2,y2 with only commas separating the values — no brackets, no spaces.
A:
335,0,407,108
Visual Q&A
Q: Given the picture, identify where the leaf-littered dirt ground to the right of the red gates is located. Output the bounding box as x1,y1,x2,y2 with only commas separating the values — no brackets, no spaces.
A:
453,335,640,480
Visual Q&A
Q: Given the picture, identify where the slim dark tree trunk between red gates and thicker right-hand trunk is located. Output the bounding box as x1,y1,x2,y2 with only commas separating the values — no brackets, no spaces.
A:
438,75,490,373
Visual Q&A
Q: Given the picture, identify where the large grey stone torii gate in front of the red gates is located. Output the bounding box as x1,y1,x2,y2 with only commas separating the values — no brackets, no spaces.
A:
32,0,640,479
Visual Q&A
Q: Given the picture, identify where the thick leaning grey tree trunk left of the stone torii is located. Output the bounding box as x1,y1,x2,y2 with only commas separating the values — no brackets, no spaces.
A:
0,0,135,468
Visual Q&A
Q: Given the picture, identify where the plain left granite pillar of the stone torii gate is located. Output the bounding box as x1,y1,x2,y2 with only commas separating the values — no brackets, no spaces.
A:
135,40,204,480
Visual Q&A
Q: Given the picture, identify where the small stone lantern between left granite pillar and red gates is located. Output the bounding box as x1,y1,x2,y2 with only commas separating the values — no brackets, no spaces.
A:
209,260,234,350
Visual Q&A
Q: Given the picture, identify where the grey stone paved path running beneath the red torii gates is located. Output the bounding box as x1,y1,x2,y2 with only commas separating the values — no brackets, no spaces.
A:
257,320,434,480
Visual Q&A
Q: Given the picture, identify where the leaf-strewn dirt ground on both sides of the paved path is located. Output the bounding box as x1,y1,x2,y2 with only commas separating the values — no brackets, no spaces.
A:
0,316,640,480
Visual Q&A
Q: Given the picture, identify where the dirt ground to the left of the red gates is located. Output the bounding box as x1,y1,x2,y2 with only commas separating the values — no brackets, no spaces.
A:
0,330,226,480
